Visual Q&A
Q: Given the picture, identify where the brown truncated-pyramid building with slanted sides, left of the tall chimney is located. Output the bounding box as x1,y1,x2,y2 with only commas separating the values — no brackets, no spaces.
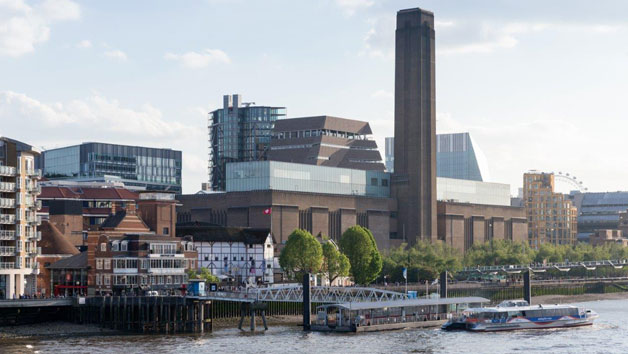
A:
268,116,385,171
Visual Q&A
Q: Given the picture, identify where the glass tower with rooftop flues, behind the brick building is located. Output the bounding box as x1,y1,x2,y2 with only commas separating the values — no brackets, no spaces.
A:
207,95,286,191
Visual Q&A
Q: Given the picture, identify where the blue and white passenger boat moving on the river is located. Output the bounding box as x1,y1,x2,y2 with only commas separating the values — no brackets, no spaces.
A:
442,300,598,332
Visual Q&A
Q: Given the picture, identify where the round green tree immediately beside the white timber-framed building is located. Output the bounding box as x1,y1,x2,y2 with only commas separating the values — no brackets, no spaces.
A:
279,229,323,276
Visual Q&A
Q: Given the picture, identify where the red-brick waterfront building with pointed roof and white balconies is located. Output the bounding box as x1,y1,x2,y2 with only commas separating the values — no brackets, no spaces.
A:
87,193,197,295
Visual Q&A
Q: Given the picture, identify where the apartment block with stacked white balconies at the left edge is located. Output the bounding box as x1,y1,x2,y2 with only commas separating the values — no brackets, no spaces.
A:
0,137,41,299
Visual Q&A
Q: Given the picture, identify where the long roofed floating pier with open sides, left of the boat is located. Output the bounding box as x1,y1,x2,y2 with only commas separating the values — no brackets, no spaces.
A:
310,297,489,332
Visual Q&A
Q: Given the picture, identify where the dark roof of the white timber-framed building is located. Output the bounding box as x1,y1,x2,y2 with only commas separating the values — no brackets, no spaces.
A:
177,222,275,244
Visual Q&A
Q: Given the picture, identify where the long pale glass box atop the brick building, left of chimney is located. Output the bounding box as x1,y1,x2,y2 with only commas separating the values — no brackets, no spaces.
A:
226,161,390,198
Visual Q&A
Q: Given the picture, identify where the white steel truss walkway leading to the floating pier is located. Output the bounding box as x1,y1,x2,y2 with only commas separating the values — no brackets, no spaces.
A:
199,285,407,303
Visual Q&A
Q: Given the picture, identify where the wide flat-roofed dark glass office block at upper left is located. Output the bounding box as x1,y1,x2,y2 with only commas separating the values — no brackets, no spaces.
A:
42,143,181,193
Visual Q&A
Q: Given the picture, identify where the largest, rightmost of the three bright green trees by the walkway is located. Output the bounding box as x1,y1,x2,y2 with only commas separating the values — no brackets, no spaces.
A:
340,225,382,285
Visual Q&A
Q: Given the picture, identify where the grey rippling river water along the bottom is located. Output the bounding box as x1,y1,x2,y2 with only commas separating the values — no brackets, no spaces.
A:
0,300,628,354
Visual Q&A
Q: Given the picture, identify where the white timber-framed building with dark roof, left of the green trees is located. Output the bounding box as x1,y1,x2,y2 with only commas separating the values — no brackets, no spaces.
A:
177,223,275,283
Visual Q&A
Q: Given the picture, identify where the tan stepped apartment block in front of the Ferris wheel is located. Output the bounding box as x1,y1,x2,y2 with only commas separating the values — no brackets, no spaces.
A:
523,171,578,248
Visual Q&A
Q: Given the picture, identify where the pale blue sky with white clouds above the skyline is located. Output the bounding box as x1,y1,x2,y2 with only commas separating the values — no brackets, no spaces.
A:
0,0,628,193
